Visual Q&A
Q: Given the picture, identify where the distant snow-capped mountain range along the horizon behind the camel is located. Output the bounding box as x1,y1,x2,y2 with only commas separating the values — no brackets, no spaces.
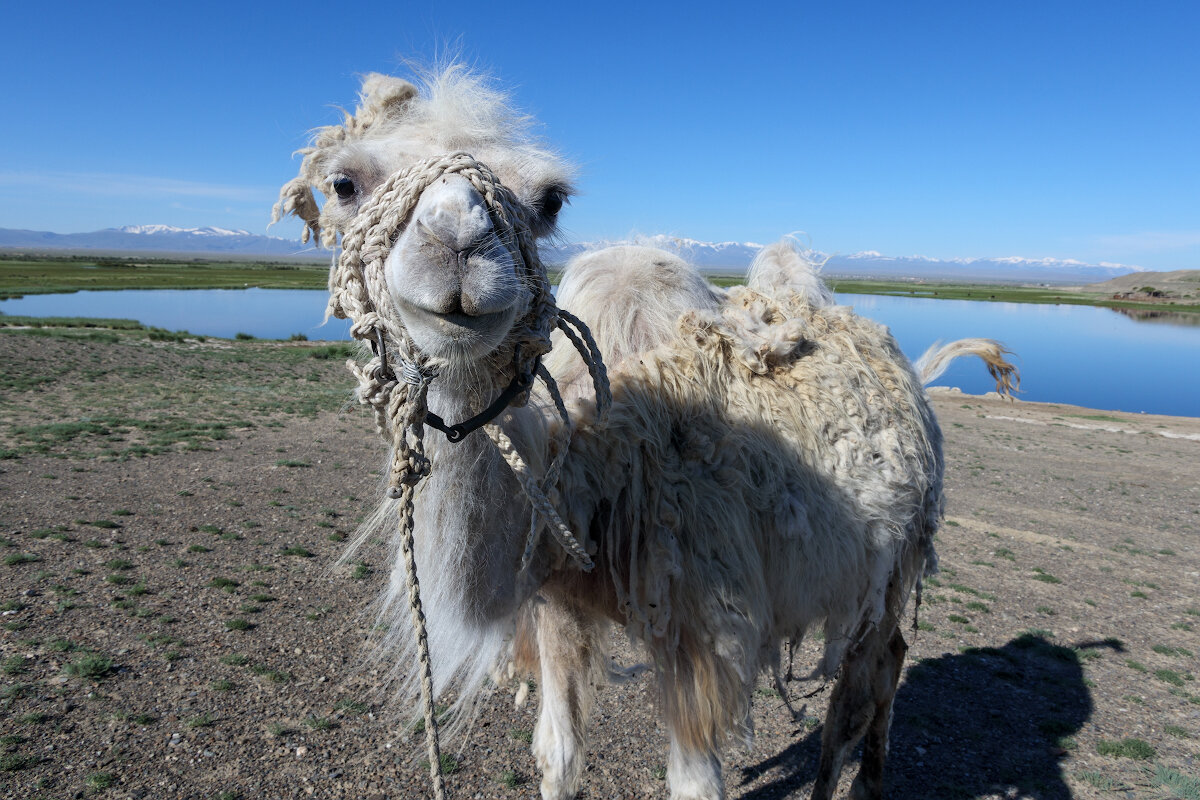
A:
0,225,1142,283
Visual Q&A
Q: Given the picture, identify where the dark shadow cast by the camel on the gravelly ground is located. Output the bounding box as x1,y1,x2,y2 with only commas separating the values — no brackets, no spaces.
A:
740,632,1123,800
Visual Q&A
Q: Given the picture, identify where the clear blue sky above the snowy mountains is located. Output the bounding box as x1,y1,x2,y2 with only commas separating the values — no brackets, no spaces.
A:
0,0,1200,269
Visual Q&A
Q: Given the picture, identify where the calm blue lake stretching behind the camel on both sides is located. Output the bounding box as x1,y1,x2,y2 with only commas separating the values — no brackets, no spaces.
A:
0,289,1200,416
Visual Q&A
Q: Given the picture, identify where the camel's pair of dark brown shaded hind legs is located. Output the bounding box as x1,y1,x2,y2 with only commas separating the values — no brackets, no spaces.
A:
812,615,908,800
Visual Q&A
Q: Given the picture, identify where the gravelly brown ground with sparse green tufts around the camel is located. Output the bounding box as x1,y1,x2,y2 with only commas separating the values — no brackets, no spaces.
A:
0,331,1200,800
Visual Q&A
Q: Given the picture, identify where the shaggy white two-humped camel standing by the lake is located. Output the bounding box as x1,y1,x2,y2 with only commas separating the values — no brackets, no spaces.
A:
276,67,1013,799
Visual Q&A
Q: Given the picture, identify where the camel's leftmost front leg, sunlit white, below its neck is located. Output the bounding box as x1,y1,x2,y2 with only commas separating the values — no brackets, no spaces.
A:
533,601,605,800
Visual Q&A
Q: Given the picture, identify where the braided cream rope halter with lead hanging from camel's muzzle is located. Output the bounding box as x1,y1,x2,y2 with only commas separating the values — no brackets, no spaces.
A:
329,152,612,800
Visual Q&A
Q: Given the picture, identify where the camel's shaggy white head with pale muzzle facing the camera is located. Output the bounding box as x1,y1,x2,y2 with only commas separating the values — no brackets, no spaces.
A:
275,66,571,369
